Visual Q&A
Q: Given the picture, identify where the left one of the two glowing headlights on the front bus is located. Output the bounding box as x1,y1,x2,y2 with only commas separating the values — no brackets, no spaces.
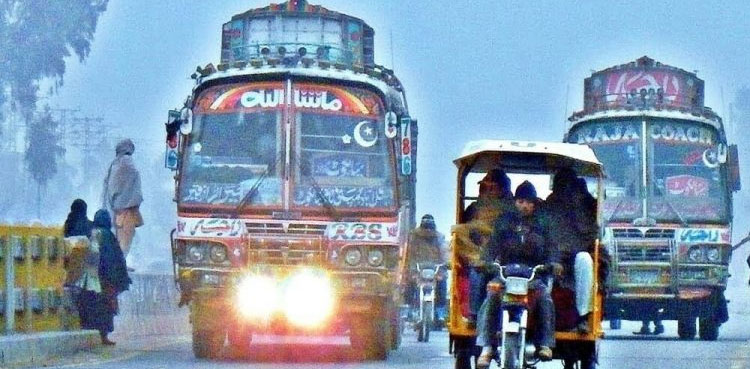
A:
235,275,279,319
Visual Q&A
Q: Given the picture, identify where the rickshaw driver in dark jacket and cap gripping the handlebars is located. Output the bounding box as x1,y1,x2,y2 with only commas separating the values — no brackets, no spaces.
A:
477,181,560,367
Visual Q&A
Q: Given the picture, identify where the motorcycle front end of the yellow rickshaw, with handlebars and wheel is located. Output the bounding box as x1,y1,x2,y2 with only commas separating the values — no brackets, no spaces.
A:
494,263,546,369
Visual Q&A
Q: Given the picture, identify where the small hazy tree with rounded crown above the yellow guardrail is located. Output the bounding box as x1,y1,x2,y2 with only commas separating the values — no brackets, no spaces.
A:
24,107,65,218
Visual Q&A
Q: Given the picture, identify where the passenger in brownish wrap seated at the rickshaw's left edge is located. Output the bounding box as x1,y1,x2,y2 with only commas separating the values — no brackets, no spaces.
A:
452,169,515,325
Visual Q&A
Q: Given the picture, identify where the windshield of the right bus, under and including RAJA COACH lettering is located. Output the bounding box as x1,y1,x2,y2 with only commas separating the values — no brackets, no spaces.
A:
568,118,728,224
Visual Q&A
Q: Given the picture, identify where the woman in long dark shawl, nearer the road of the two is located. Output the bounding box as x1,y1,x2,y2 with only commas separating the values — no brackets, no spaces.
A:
92,209,131,345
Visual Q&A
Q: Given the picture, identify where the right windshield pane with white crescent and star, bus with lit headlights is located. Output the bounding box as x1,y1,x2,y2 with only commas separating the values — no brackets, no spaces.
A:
292,85,395,209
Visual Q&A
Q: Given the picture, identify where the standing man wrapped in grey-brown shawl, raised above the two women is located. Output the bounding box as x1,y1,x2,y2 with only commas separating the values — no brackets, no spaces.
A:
102,139,143,256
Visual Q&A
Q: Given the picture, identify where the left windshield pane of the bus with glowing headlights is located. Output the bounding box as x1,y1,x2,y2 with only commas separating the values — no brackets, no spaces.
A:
180,84,283,206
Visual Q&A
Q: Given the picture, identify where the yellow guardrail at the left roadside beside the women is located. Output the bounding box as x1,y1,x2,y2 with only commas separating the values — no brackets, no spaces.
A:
0,225,78,334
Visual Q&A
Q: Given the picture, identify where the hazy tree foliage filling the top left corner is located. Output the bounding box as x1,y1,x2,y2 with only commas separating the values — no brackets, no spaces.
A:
0,0,109,119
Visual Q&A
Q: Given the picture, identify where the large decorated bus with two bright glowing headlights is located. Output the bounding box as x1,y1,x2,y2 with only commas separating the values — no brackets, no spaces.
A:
166,0,416,359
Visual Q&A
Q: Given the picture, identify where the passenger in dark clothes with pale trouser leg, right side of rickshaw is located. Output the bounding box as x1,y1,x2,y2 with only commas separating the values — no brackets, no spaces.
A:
544,168,599,333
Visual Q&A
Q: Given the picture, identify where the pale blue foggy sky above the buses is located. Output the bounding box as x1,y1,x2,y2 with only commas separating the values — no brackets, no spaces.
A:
49,0,750,238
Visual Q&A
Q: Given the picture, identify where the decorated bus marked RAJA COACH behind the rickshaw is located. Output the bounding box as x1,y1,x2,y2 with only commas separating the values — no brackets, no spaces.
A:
565,57,740,340
